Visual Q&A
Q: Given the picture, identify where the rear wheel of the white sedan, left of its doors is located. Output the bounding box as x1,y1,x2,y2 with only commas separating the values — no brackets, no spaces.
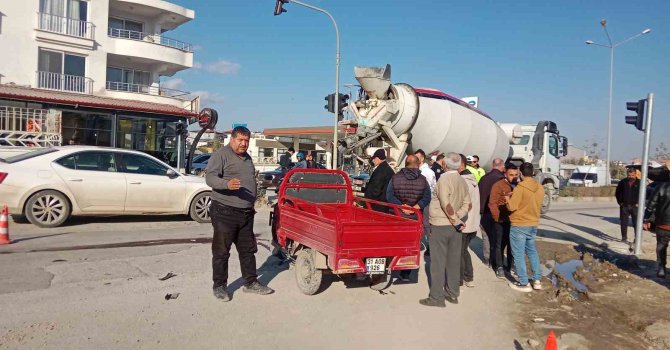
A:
25,190,71,227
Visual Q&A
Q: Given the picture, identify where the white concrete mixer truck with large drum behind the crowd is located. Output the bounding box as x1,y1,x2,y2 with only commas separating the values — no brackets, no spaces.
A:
342,65,567,211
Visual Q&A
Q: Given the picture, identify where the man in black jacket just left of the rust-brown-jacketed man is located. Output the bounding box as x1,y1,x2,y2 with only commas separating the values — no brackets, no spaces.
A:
479,158,505,265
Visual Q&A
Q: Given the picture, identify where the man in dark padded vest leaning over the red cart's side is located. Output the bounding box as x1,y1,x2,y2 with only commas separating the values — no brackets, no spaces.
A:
386,155,431,281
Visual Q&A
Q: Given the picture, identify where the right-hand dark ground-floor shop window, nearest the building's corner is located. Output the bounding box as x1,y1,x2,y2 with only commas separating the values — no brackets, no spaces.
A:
116,116,177,165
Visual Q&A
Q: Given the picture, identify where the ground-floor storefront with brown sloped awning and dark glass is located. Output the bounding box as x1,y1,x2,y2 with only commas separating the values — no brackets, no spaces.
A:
0,86,196,166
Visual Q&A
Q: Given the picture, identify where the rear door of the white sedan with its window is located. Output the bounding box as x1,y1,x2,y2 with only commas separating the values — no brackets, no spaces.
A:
53,151,126,214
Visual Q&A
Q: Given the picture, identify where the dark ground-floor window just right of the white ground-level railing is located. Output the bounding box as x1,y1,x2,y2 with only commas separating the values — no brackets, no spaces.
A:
63,111,114,147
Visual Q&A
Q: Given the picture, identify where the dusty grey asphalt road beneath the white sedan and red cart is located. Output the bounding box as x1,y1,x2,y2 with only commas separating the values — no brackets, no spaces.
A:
0,203,648,349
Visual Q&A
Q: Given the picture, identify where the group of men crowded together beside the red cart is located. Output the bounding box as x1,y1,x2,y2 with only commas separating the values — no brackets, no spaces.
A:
365,149,544,307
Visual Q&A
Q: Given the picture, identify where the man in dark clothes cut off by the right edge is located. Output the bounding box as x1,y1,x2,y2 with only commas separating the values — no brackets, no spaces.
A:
644,172,670,278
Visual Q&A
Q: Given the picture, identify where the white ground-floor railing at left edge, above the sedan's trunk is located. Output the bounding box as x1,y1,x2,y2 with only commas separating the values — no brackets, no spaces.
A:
0,106,62,147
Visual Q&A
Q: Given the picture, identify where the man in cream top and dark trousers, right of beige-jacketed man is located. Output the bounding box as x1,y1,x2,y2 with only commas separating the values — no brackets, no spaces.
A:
458,154,481,288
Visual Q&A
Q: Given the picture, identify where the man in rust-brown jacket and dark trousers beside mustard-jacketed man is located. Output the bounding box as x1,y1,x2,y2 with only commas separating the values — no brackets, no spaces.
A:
489,163,519,279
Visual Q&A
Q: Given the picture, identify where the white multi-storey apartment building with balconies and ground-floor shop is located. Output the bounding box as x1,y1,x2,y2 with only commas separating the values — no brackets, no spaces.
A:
0,0,200,165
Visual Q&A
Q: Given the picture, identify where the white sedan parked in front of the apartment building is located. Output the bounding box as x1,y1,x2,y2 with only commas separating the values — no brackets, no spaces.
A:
0,146,211,227
